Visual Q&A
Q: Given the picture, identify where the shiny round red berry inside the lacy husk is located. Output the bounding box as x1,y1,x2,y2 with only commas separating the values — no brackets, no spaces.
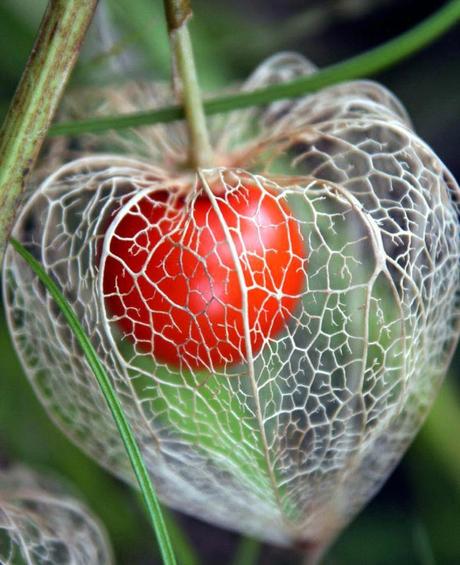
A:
102,179,306,369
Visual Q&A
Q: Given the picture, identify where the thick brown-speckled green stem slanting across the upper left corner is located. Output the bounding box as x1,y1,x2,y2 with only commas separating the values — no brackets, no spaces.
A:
0,0,97,260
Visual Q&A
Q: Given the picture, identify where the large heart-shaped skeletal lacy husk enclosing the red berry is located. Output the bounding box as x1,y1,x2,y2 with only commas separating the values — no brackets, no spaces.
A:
4,54,460,545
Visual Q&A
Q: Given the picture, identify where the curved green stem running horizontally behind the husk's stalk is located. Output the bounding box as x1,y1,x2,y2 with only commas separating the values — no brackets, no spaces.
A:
49,0,460,136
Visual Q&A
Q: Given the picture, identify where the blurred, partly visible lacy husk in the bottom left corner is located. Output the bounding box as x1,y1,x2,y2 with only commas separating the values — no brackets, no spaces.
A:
0,466,112,565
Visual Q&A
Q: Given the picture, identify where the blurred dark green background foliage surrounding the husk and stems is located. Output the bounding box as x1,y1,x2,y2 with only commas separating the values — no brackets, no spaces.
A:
0,0,460,565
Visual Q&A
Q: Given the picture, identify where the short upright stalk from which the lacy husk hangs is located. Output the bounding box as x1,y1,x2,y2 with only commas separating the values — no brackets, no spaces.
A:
164,0,213,168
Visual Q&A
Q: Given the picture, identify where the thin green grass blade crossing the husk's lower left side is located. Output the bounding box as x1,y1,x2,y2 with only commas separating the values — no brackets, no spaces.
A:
10,239,176,565
